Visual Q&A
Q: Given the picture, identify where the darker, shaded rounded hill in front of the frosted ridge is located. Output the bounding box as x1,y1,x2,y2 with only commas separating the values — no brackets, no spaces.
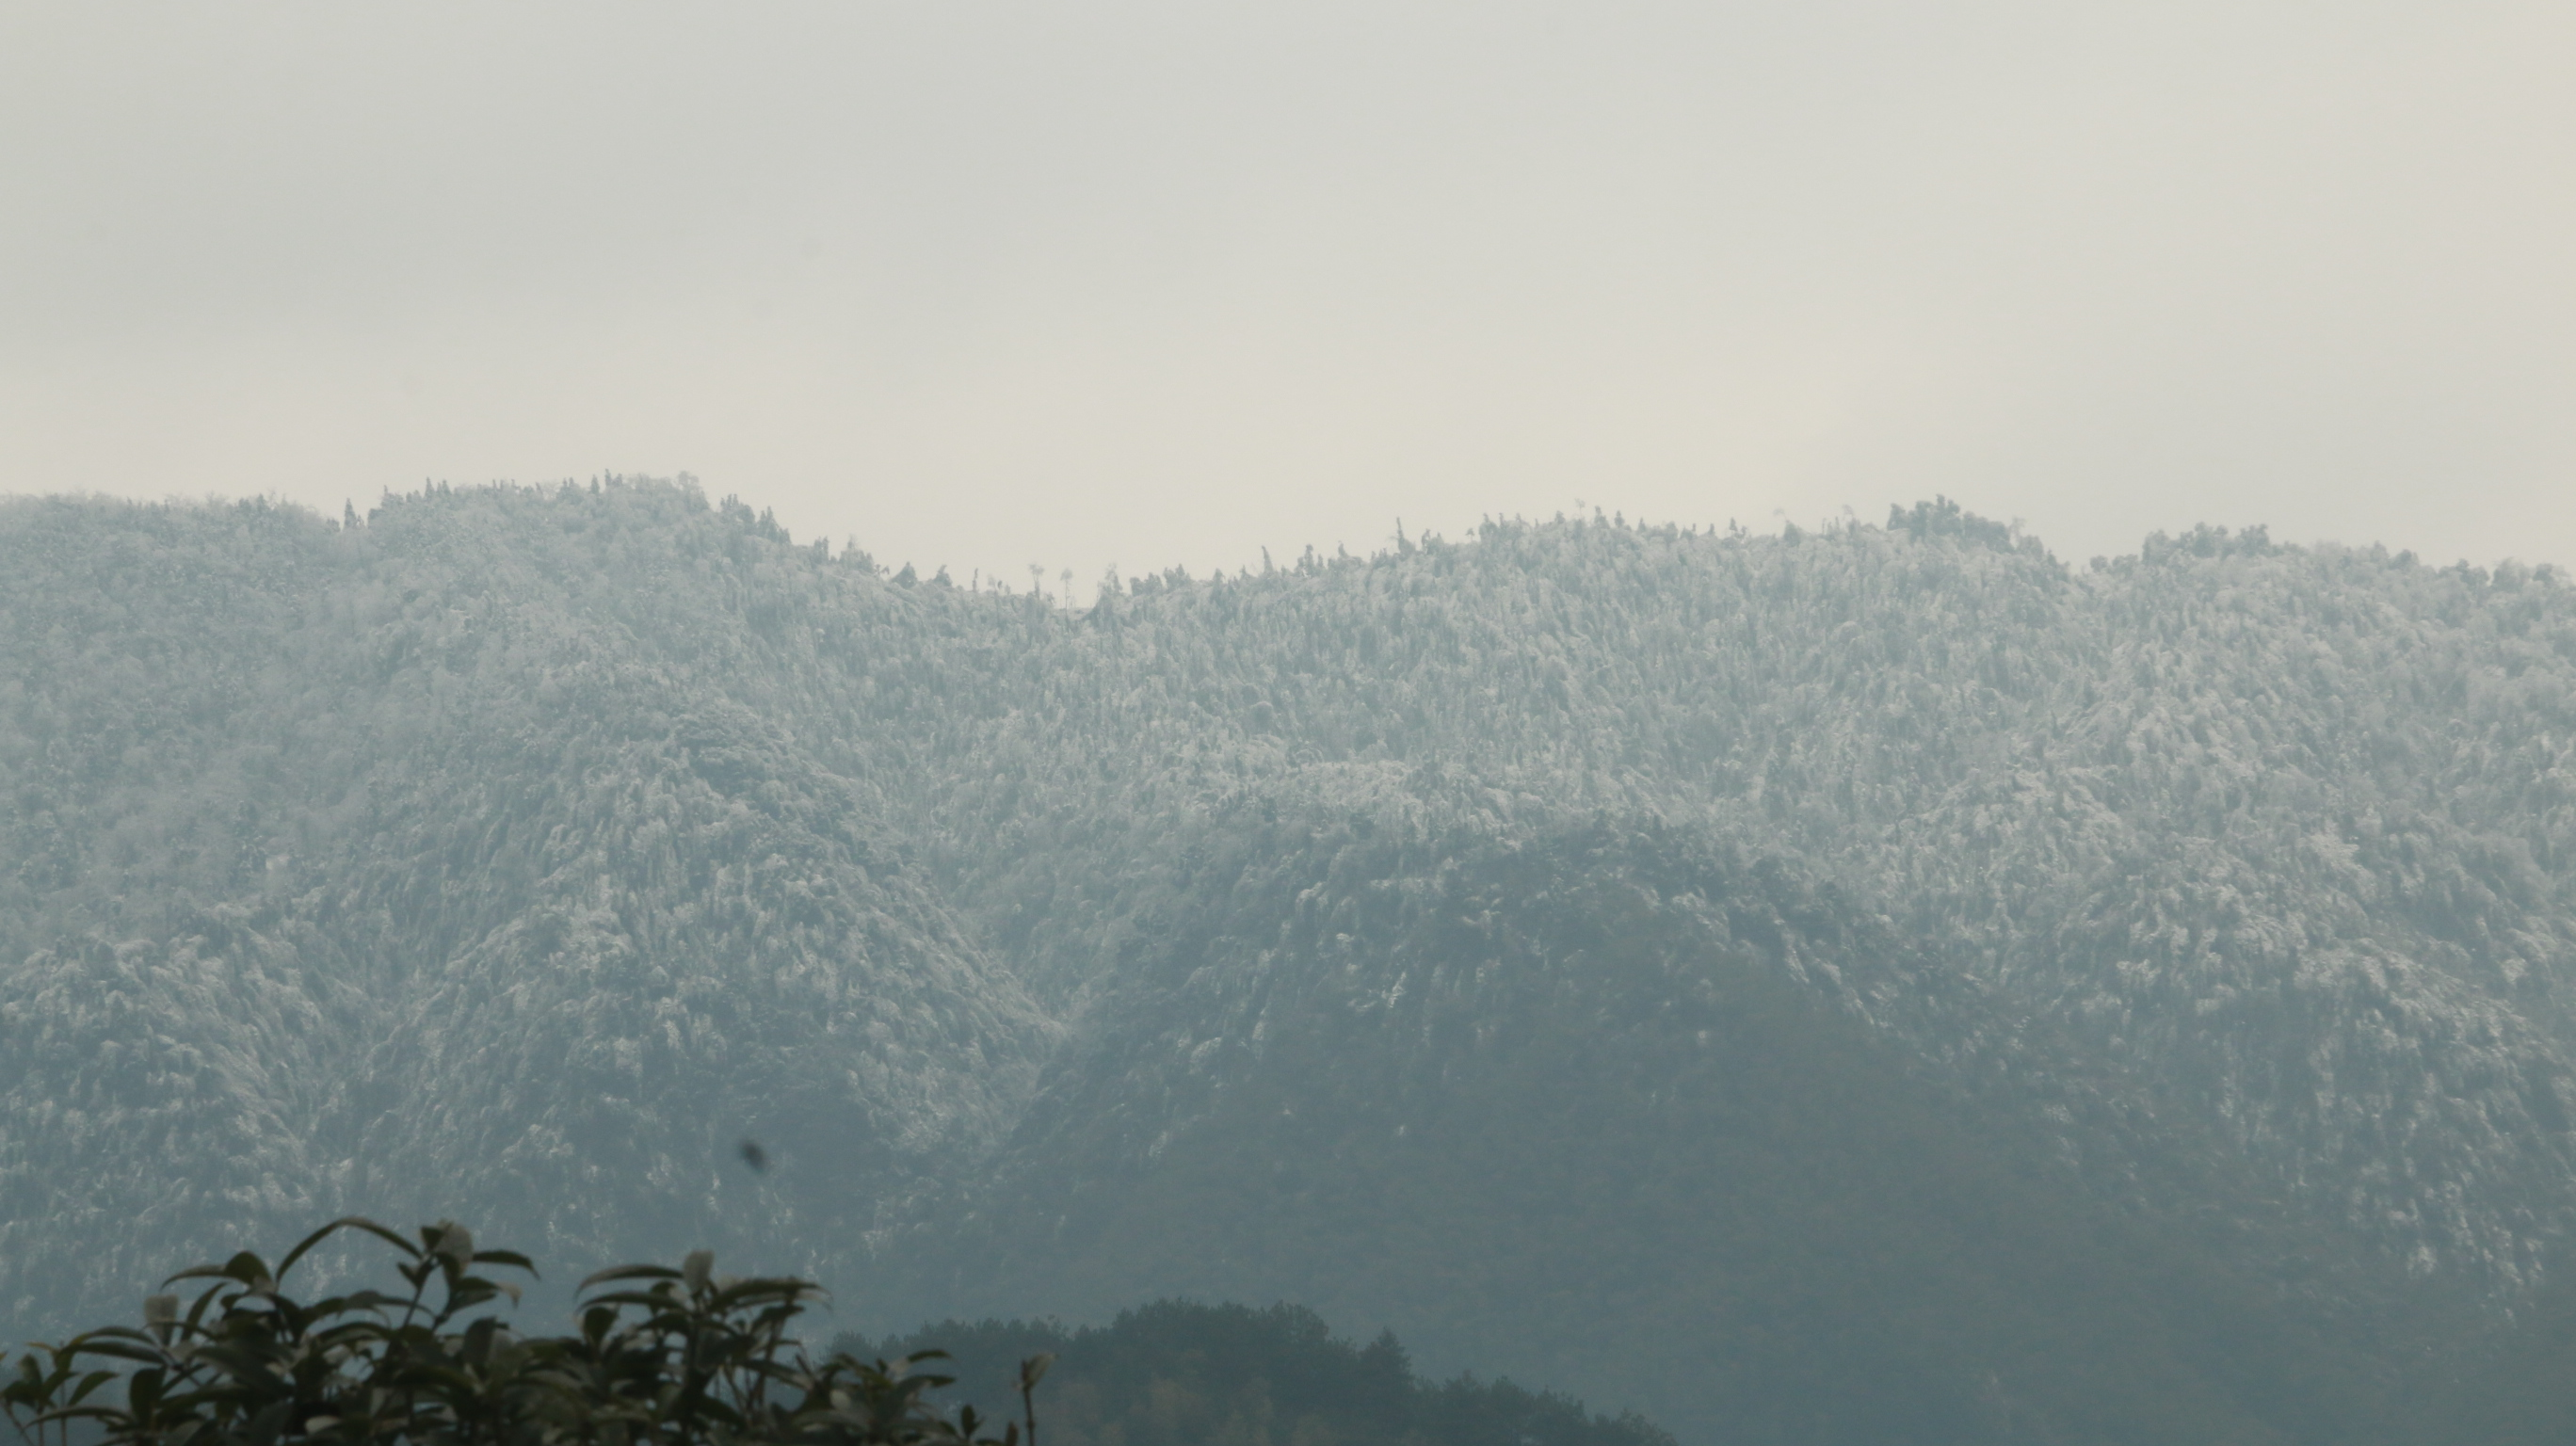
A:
902,817,2431,1441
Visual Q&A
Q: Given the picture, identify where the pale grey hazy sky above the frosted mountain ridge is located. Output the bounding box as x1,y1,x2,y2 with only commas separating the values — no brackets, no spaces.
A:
0,0,2576,595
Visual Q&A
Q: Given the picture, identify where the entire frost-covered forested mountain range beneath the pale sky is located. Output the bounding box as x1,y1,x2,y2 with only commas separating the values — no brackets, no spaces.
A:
0,482,2576,1441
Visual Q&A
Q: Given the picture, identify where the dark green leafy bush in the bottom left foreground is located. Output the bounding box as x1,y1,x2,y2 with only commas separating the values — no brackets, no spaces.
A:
0,1216,1049,1446
